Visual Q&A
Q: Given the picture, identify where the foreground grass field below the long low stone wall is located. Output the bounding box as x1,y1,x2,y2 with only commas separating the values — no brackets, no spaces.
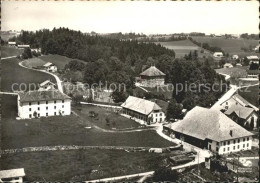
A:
1,149,177,182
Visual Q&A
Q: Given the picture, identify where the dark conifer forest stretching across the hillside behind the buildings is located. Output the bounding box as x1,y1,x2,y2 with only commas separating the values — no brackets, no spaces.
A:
10,28,228,109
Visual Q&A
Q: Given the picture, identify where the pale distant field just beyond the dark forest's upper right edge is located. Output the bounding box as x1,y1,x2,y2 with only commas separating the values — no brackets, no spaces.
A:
156,40,209,58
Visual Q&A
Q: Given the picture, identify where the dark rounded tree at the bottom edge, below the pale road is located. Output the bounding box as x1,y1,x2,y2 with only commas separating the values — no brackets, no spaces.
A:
152,167,179,182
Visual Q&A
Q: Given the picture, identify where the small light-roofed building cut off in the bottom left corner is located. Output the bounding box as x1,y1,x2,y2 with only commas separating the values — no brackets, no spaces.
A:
0,168,25,183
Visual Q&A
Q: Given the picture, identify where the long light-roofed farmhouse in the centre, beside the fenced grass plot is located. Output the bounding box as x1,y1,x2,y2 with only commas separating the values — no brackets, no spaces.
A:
121,96,165,125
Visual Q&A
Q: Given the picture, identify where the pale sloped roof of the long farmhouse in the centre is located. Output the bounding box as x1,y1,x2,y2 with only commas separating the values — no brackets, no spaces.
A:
121,96,161,115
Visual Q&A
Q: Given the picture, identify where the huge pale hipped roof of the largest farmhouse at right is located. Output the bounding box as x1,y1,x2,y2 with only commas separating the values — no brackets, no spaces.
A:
169,106,253,142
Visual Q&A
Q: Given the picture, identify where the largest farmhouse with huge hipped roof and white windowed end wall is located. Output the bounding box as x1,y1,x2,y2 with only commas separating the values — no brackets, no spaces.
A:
164,106,253,154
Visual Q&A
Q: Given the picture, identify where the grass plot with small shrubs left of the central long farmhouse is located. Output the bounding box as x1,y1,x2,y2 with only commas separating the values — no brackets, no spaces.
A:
74,105,141,129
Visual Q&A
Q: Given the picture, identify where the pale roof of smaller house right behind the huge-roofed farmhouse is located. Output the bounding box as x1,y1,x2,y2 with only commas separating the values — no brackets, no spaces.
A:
225,104,255,119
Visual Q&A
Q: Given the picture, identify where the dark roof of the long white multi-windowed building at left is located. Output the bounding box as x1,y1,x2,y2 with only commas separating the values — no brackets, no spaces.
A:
18,90,71,102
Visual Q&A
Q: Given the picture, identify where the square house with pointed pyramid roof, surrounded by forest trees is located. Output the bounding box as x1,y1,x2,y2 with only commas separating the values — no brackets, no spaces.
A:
139,66,165,87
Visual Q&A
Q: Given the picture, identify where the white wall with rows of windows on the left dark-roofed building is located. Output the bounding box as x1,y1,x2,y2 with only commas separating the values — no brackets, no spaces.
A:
18,97,71,119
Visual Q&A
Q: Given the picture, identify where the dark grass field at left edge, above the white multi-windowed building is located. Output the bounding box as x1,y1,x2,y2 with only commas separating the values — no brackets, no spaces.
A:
1,58,56,92
